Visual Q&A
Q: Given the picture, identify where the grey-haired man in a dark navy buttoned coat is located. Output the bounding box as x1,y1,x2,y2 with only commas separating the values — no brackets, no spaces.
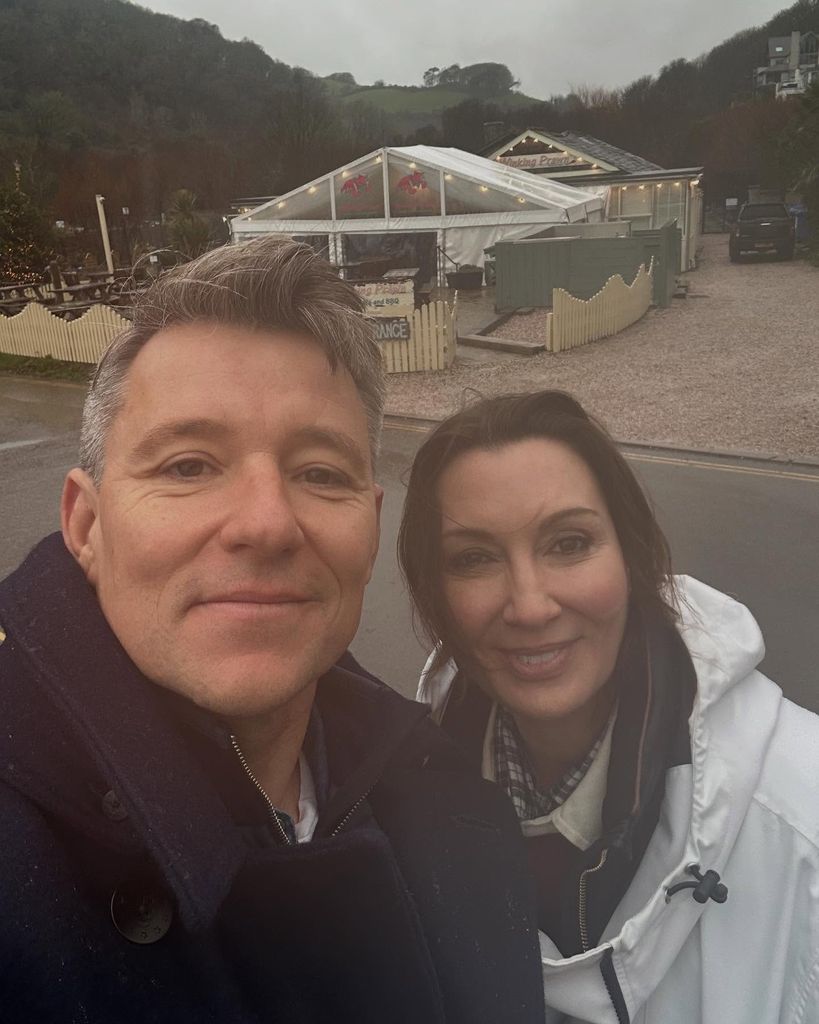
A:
0,240,543,1024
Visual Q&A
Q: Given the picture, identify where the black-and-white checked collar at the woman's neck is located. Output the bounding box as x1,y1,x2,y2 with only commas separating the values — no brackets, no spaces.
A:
491,705,608,821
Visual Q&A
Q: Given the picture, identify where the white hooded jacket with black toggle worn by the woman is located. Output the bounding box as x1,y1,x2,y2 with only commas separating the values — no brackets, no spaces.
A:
418,577,819,1024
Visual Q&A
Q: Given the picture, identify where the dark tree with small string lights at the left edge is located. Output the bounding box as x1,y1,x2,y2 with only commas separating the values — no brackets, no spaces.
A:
0,185,53,284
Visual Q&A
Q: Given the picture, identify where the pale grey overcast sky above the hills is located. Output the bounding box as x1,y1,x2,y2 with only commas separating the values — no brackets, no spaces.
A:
141,0,799,98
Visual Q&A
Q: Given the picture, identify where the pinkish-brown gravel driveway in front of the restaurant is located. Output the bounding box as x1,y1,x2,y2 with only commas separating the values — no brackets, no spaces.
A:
387,234,819,459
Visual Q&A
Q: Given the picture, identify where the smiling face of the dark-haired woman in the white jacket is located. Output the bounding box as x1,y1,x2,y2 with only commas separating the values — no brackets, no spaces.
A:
438,438,629,721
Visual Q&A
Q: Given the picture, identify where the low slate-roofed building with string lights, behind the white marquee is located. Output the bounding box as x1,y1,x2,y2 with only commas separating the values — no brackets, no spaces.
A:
481,128,702,270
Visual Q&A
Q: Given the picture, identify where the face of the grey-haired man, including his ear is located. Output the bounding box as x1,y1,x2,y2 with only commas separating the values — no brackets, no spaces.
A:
63,324,381,717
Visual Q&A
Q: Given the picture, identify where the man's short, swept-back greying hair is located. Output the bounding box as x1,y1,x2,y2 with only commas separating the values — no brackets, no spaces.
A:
80,237,385,484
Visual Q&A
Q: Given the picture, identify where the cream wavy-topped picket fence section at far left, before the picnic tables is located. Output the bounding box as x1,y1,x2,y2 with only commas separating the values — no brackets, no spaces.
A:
0,302,129,362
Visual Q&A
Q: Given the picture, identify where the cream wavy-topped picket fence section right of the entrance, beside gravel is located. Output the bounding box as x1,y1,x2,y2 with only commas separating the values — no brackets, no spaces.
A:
546,257,654,352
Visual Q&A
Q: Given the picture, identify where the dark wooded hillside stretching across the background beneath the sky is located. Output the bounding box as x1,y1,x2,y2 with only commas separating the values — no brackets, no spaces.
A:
0,0,819,239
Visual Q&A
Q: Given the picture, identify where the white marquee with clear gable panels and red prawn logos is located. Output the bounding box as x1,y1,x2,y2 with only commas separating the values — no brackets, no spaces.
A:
231,145,605,281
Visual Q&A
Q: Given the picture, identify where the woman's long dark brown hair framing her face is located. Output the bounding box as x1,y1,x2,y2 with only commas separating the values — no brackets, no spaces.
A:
398,391,677,666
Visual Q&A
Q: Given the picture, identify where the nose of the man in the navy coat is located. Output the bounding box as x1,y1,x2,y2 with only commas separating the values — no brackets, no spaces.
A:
221,463,304,554
